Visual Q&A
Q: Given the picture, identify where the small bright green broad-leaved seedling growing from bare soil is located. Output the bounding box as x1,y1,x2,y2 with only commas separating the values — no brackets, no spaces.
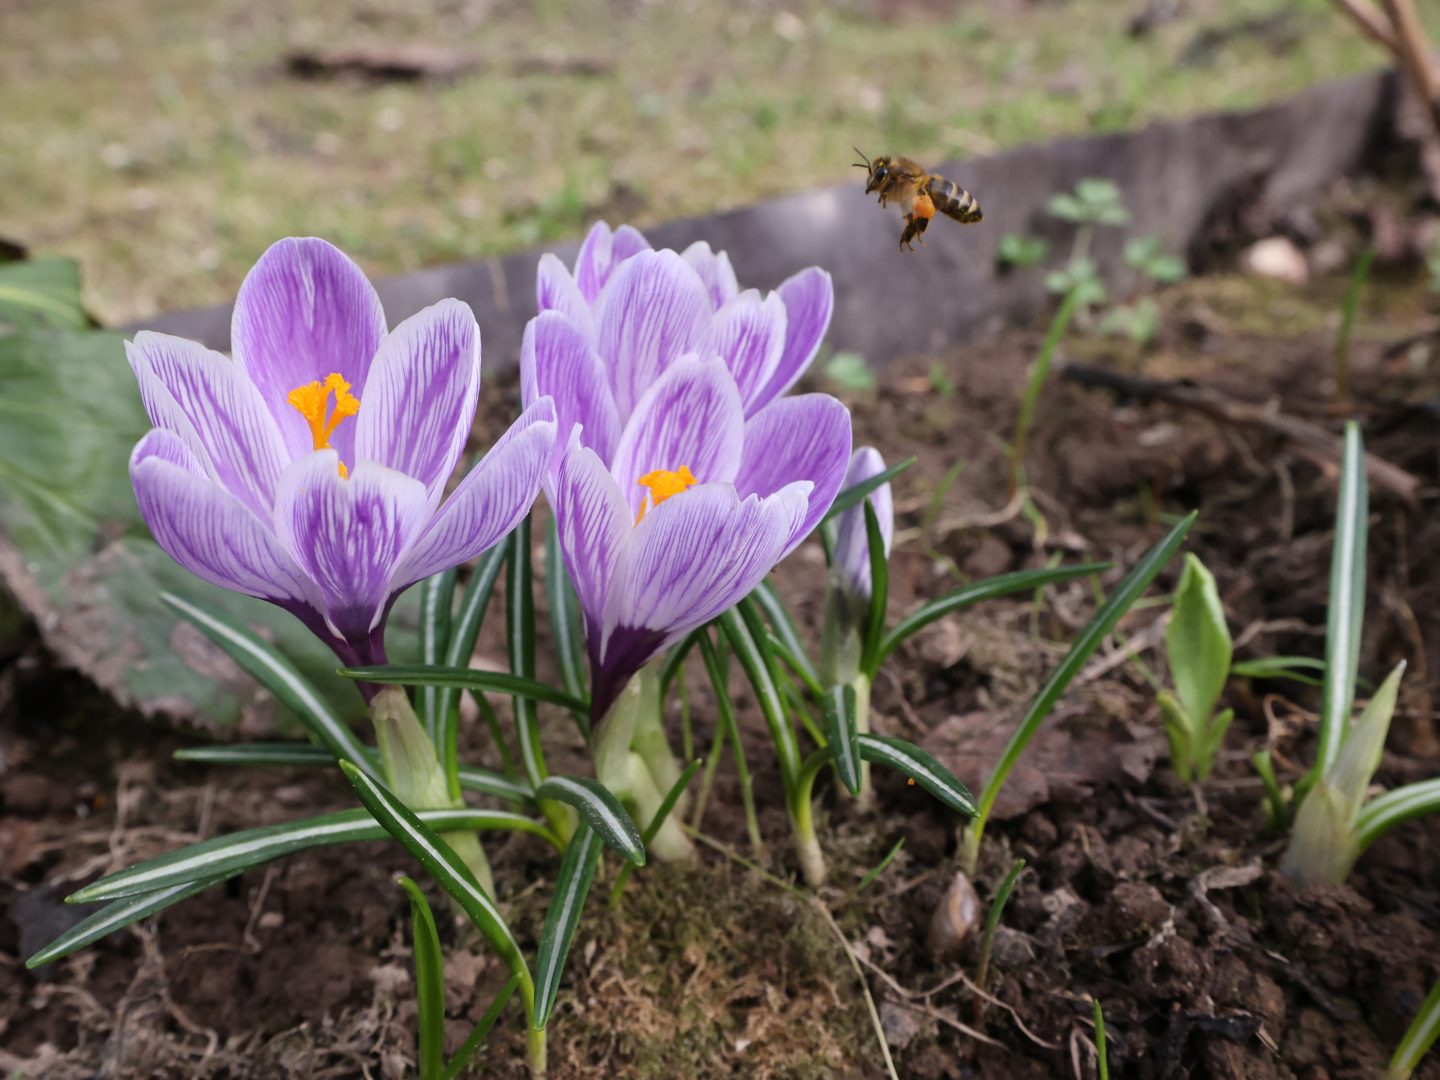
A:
1159,554,1234,783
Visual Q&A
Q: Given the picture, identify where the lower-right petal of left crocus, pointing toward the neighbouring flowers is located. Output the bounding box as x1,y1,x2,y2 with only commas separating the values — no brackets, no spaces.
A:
392,397,556,592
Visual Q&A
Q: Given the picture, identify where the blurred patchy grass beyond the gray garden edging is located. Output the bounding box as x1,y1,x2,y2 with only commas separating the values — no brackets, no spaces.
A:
0,0,1434,321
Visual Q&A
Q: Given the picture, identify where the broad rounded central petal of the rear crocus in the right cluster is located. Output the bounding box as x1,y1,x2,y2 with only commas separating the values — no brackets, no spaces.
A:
596,251,711,422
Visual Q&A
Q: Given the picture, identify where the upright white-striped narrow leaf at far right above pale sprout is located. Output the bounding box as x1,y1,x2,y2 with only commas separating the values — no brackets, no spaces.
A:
1310,420,1369,778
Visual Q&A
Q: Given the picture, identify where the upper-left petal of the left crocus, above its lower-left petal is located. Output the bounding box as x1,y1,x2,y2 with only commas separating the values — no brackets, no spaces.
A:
125,331,285,518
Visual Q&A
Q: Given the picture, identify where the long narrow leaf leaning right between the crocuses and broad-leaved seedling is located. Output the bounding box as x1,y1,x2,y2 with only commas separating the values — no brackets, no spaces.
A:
965,511,1195,870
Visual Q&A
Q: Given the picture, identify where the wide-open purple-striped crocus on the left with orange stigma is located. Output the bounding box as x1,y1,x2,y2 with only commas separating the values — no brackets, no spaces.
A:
125,239,556,676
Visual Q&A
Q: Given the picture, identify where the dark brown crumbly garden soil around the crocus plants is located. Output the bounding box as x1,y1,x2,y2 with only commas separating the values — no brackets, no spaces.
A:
0,260,1440,1080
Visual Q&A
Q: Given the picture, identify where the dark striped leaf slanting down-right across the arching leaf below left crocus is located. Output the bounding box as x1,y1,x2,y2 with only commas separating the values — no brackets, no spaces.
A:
340,762,534,1012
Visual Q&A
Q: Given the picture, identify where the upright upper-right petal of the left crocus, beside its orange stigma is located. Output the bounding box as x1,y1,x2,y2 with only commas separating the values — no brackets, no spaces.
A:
353,300,480,498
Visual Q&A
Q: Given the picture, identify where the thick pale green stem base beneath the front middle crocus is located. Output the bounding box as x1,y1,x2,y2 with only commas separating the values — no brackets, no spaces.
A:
595,664,694,861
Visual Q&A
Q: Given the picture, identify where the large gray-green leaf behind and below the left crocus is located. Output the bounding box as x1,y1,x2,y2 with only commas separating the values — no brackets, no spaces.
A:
0,330,416,737
